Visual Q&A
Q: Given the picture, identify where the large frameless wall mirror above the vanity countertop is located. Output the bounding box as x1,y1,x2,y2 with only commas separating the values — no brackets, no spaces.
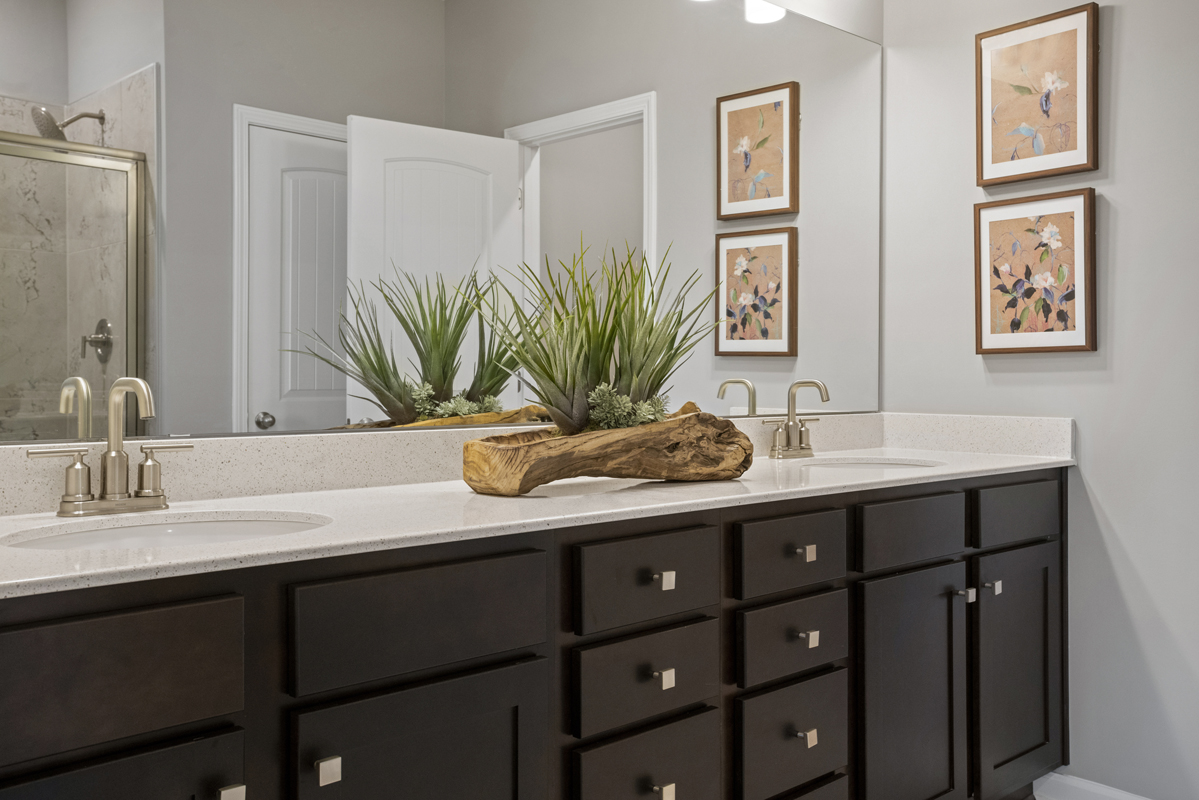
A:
0,0,881,443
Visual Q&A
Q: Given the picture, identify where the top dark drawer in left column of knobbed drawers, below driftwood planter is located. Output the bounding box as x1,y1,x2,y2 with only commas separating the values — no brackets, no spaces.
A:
574,527,721,636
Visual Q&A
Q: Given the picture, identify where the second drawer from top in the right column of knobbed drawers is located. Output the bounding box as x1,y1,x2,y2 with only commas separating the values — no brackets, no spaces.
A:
737,589,849,688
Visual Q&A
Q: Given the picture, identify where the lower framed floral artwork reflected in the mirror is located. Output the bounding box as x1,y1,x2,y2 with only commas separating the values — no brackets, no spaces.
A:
716,228,799,356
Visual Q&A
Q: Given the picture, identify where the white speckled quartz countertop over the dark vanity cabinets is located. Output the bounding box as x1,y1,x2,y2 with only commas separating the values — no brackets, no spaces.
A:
0,441,1074,597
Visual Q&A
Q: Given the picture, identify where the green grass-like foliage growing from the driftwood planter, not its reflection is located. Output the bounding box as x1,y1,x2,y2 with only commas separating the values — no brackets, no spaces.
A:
478,246,712,434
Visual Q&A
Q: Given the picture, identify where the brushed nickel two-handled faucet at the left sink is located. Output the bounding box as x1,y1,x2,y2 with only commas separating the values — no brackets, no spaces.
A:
26,378,192,517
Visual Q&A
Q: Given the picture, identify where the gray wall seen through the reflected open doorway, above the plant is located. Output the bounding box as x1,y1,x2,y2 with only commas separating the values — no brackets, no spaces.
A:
538,125,644,277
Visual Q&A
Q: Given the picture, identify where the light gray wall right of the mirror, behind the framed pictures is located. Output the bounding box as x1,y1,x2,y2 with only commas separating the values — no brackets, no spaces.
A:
882,0,1199,800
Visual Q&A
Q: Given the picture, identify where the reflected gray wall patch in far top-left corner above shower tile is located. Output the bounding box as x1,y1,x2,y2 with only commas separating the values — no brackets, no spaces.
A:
0,0,67,103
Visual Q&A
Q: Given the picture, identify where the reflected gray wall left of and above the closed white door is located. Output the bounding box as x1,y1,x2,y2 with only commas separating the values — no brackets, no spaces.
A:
156,0,445,433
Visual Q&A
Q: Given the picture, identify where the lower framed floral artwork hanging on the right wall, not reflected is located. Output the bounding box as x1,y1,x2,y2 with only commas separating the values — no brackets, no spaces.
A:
975,188,1096,355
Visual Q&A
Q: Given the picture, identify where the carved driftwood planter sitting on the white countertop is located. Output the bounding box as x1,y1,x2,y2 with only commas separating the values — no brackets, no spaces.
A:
462,403,753,497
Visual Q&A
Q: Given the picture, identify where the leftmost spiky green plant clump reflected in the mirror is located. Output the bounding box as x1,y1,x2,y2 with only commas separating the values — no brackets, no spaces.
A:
289,283,417,425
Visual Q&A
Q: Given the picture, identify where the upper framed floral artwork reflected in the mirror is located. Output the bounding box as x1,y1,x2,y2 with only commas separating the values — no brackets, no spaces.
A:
716,80,800,219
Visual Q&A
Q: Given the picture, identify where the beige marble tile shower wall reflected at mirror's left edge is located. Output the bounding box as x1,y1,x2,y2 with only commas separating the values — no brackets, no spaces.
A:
0,65,158,440
